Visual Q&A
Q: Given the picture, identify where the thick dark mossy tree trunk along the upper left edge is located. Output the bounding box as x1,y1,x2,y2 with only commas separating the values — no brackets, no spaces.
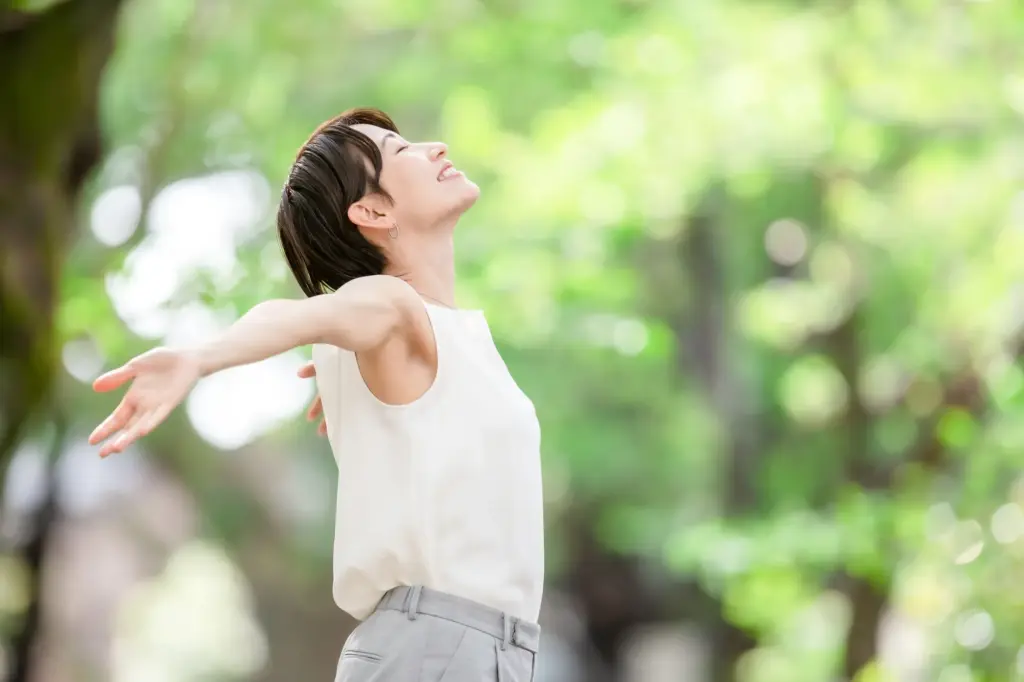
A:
0,0,122,477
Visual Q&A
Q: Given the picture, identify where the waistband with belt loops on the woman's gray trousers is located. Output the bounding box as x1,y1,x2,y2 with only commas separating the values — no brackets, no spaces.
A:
377,586,541,653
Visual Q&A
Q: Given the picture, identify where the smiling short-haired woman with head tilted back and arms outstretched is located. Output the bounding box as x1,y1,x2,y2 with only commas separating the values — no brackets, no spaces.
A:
90,110,544,682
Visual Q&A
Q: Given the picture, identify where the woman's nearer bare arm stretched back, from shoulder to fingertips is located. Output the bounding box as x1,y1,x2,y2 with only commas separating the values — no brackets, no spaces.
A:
89,275,424,457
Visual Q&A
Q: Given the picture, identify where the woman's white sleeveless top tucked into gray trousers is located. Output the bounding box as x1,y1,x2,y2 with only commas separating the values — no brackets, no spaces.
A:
313,304,544,623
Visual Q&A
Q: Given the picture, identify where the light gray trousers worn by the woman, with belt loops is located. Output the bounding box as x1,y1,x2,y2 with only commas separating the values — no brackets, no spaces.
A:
335,587,541,682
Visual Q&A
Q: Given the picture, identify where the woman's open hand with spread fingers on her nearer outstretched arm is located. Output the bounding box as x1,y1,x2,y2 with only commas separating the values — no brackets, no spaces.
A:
89,348,200,457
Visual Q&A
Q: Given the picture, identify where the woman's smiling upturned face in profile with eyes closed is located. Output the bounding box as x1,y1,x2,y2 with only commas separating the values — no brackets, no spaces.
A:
352,124,480,231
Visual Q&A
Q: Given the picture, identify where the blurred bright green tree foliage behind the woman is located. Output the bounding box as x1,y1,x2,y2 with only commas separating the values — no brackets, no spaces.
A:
2,0,1024,682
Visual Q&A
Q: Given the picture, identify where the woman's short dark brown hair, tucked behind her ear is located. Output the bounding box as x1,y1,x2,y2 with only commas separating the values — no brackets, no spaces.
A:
278,109,398,296
